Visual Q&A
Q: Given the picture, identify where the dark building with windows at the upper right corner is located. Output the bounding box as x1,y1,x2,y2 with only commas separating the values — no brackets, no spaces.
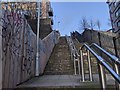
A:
107,0,120,33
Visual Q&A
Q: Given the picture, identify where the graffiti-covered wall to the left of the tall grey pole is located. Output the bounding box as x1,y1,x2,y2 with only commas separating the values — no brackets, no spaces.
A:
0,10,36,88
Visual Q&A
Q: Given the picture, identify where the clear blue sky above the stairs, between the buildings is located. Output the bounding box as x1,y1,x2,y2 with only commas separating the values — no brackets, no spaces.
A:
51,2,110,35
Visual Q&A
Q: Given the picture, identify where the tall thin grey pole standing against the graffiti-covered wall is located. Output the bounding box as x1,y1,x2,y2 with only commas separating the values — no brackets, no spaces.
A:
35,2,40,76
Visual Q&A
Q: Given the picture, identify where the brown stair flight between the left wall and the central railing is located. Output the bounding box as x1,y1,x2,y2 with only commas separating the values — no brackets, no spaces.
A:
44,37,74,75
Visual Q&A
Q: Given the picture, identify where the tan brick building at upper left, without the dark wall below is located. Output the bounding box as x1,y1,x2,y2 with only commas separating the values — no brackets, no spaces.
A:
2,0,53,25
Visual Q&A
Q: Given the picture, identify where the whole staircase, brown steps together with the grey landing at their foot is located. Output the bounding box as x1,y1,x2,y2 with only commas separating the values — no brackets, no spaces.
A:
16,37,115,90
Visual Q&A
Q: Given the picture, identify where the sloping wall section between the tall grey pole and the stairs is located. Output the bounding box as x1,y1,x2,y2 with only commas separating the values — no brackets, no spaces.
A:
39,31,60,74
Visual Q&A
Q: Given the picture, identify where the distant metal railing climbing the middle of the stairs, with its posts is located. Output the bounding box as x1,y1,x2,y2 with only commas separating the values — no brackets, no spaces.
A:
66,36,80,75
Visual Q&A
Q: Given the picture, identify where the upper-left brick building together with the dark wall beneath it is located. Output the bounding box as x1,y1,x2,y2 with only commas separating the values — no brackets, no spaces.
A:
2,0,53,39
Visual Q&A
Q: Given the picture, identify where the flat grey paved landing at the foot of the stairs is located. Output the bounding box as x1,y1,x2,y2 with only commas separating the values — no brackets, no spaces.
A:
17,74,115,90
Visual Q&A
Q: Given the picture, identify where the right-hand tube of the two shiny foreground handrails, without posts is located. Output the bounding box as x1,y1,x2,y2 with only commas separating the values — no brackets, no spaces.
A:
90,43,120,64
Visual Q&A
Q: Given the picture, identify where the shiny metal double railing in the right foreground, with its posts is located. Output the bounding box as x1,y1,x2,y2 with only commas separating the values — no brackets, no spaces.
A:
80,44,120,89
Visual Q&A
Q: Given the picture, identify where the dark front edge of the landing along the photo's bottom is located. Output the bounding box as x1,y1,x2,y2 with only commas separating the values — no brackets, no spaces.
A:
15,84,116,90
